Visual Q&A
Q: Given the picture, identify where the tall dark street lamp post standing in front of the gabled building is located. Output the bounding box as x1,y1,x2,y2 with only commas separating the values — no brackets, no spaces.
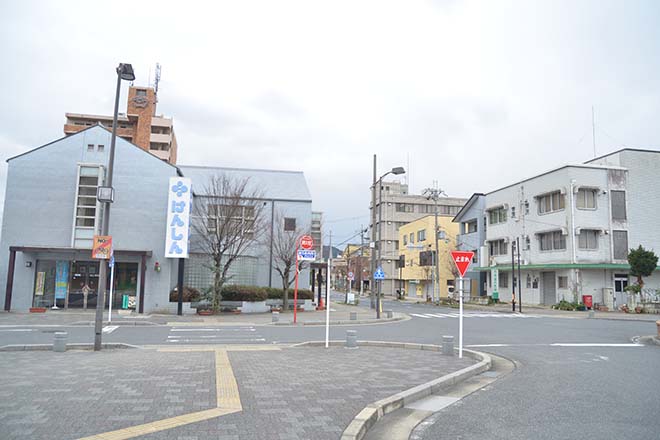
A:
94,63,135,351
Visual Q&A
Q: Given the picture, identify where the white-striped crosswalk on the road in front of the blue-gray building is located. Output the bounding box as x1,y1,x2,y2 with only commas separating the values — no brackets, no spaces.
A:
167,326,266,344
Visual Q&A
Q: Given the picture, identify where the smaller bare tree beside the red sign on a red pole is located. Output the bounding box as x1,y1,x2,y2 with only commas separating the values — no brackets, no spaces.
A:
272,213,309,310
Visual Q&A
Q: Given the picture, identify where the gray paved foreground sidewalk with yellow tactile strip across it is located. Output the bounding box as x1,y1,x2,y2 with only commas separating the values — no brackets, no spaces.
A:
0,346,475,440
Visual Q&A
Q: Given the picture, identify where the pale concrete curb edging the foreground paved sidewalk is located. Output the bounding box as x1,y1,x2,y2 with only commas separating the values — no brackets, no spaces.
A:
291,341,492,440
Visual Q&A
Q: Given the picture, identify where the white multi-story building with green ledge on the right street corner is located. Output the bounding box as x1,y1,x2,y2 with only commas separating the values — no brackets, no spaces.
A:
480,149,660,308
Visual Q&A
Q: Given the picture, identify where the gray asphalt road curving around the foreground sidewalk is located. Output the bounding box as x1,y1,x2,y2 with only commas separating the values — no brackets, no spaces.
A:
0,294,660,440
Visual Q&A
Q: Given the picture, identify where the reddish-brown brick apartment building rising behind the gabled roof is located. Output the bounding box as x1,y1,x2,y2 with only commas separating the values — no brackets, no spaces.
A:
64,86,177,164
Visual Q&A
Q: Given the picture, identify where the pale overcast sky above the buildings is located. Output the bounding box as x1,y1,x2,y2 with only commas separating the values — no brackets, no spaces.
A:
0,0,660,243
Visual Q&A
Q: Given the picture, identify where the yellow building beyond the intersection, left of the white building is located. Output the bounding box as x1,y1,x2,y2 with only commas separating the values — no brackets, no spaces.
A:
397,215,459,299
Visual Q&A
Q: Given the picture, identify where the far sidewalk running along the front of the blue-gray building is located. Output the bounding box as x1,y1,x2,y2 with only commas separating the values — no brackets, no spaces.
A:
0,302,407,326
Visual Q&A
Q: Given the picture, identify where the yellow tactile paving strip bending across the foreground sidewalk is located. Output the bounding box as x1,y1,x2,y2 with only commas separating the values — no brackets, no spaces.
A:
79,346,245,440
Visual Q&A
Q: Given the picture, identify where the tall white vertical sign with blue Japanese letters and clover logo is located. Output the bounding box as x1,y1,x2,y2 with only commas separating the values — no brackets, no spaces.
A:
165,177,192,258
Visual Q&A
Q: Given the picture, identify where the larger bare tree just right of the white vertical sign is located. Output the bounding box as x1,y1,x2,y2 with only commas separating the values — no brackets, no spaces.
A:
192,174,265,312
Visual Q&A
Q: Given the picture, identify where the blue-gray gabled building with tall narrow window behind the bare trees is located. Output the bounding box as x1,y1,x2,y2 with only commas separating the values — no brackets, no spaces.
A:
0,125,311,313
